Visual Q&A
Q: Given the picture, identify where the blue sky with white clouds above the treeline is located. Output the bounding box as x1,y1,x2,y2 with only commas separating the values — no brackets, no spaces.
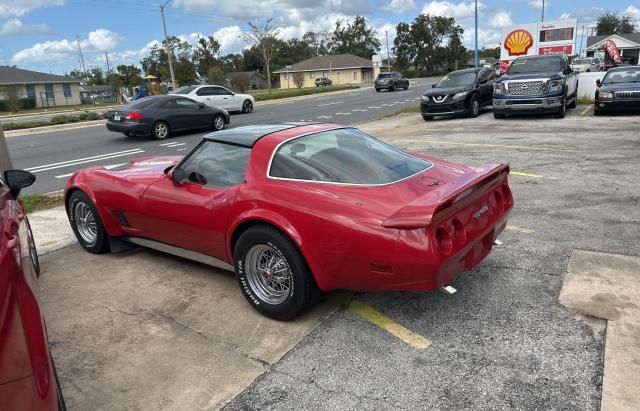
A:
0,0,640,74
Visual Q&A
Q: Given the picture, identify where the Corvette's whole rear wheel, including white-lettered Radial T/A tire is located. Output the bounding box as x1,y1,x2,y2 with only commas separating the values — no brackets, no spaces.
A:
234,226,319,321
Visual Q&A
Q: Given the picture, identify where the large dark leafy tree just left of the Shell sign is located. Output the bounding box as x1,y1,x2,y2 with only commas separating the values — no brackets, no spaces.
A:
393,14,466,74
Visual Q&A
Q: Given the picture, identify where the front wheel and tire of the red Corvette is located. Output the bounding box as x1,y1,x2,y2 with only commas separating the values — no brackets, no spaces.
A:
67,191,109,254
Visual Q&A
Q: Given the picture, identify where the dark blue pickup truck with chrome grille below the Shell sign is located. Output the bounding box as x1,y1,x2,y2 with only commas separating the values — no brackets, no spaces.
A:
493,55,578,118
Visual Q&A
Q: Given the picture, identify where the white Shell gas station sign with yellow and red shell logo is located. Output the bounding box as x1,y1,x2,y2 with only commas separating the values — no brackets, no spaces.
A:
500,19,578,70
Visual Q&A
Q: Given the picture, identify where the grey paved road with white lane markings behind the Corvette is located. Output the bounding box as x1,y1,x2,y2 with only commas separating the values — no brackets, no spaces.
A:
7,78,436,194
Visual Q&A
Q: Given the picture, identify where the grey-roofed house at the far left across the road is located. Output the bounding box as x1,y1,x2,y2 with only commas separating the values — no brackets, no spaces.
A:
0,66,80,108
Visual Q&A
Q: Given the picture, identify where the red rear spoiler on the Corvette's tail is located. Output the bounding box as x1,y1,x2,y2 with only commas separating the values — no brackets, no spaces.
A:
382,164,509,230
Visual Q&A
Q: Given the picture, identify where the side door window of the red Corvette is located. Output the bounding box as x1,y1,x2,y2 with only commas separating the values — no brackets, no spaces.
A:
181,141,251,188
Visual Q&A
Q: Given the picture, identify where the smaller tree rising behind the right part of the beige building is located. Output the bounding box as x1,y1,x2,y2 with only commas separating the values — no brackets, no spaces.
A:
330,16,380,59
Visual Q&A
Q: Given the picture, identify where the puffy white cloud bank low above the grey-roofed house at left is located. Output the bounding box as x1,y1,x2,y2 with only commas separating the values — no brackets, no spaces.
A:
11,28,121,64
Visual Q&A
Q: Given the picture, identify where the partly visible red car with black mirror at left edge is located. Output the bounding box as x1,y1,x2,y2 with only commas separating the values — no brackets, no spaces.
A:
0,170,66,411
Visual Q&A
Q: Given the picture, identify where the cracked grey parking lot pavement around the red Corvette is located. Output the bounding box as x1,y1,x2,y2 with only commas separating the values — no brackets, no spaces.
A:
41,107,640,410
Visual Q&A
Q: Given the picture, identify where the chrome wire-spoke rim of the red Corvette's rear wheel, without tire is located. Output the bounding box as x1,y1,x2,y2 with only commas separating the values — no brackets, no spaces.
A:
245,244,293,305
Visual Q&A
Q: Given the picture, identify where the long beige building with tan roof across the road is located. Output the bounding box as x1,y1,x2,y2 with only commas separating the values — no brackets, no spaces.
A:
273,54,377,88
